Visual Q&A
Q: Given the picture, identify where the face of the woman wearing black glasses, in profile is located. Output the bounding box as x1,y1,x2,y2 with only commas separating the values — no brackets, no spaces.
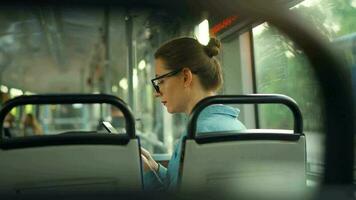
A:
155,58,187,113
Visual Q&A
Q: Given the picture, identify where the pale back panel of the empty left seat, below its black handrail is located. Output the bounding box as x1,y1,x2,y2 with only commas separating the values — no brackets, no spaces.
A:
0,134,142,195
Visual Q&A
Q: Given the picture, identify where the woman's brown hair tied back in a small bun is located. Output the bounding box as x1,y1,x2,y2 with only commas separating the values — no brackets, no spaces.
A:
154,37,223,91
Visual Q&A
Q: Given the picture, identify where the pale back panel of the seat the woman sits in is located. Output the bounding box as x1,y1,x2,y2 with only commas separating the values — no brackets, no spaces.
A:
180,129,306,197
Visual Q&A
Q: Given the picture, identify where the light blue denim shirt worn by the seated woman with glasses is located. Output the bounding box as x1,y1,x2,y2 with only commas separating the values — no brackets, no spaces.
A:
144,105,246,190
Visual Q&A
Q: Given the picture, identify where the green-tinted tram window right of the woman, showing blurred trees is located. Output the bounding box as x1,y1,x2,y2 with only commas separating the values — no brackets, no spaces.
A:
253,21,323,184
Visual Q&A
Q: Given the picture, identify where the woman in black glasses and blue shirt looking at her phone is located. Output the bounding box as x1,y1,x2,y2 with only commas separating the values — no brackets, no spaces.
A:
141,37,245,189
